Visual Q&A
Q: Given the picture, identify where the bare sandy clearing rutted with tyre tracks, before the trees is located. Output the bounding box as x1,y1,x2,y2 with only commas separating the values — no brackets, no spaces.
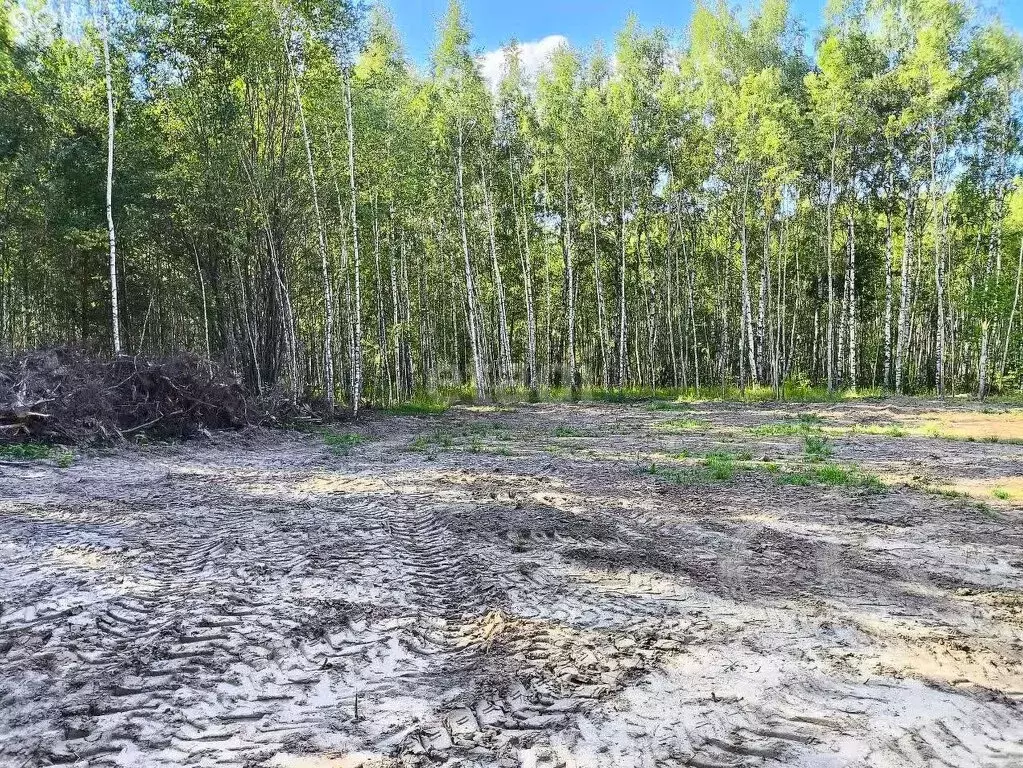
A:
0,401,1023,768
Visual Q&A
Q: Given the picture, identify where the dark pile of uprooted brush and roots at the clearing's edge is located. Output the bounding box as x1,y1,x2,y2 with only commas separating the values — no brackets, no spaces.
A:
0,348,300,445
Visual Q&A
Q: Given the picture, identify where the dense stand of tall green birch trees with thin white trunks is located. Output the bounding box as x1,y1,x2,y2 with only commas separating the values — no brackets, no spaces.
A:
0,0,1023,411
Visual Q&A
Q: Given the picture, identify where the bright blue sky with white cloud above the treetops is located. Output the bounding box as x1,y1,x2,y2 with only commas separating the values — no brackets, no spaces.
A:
381,0,1023,65
